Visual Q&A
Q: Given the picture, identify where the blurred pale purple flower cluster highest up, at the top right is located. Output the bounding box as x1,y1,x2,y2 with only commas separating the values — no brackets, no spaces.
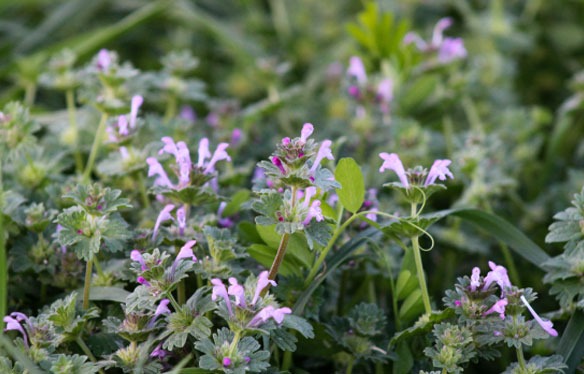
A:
404,18,466,64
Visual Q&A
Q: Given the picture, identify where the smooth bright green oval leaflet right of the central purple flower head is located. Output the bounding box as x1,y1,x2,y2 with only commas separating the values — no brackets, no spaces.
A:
335,157,365,213
